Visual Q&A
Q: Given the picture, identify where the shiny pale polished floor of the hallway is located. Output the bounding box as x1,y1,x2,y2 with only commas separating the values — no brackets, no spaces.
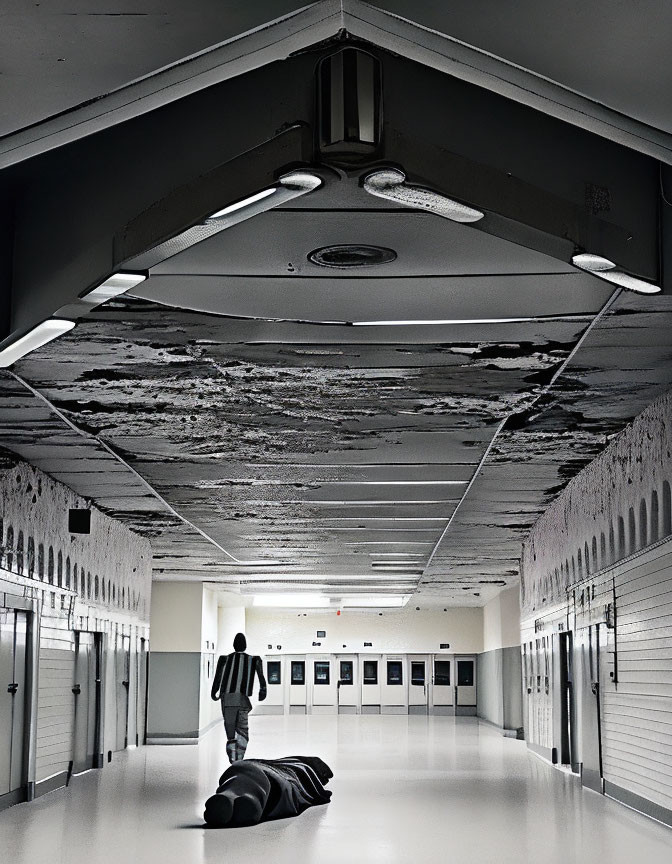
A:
0,715,672,864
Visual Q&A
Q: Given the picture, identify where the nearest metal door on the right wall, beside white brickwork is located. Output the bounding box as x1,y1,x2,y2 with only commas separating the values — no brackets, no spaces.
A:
575,624,607,792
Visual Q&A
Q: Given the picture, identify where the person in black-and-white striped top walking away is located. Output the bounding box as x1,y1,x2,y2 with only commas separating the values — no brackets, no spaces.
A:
210,633,266,764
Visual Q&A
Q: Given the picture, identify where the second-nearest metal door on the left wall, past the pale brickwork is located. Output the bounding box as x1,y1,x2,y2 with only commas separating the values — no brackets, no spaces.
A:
72,630,101,773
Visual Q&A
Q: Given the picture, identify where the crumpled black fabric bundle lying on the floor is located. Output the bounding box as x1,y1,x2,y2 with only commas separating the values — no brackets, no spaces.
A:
203,756,334,828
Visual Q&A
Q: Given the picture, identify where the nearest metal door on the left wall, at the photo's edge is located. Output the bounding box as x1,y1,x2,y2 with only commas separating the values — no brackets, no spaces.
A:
0,608,28,807
